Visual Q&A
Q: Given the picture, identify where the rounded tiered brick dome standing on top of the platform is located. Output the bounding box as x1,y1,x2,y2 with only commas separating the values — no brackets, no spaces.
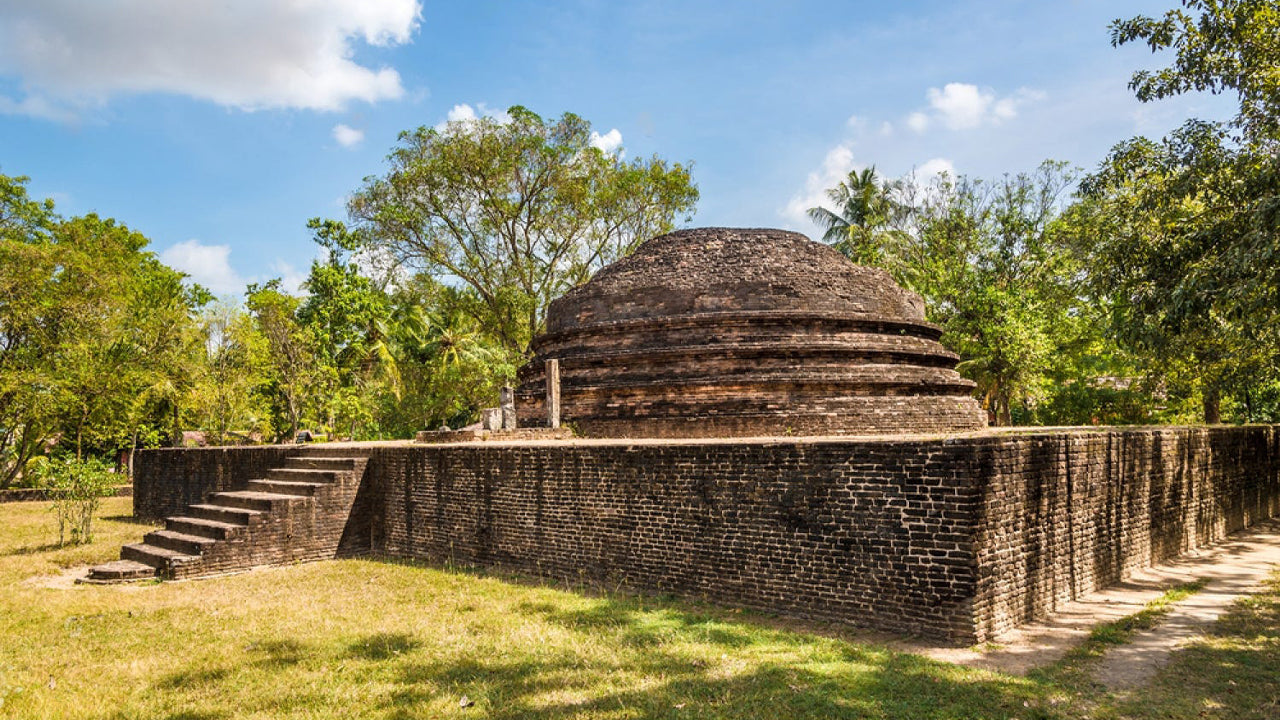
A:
517,228,986,437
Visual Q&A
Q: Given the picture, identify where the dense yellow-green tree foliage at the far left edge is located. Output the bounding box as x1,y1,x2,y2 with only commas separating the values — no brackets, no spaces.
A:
0,170,209,487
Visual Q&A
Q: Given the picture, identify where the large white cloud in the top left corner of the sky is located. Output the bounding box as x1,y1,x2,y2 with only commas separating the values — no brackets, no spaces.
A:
0,0,421,119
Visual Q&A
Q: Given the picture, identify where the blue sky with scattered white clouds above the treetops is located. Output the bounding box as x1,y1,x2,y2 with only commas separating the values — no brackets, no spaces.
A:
0,0,1231,295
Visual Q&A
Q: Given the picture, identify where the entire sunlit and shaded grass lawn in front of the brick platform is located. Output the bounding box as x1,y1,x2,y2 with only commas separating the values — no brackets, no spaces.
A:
0,498,1280,720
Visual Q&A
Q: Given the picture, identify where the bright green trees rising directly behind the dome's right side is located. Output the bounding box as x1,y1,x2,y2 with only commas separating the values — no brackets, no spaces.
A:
812,163,1088,425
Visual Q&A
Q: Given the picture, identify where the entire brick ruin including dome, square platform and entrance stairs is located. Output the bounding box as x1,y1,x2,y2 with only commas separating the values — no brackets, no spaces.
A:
95,228,1280,643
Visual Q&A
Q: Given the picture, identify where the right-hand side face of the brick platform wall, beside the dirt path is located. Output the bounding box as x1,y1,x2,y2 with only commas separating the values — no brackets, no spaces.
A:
973,425,1280,637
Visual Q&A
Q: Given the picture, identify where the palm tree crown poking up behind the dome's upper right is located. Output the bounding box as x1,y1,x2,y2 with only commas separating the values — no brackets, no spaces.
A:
809,165,897,265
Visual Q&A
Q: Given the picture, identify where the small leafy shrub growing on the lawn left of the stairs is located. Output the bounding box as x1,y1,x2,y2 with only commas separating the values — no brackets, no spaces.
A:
28,456,118,544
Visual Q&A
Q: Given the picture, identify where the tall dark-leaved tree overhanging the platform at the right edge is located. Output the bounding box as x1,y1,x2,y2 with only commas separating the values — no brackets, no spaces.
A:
1083,0,1280,423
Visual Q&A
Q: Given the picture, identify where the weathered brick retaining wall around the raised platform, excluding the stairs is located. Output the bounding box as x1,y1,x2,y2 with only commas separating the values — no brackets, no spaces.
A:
137,427,1280,643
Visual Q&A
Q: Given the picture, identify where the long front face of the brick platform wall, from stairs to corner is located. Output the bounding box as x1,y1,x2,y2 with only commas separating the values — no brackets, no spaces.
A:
369,441,979,639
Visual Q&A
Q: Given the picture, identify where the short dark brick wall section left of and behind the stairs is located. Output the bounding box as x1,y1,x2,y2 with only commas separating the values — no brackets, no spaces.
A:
133,445,298,520
